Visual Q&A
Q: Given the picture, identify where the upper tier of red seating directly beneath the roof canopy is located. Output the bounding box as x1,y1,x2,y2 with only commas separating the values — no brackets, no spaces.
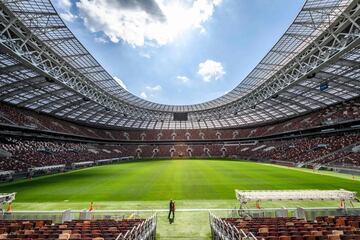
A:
0,98,360,141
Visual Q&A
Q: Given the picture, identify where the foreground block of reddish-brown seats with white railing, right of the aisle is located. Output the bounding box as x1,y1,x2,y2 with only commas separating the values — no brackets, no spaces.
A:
211,216,360,240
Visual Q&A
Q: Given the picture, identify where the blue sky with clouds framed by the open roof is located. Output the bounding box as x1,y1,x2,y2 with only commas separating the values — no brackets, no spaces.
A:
52,0,304,105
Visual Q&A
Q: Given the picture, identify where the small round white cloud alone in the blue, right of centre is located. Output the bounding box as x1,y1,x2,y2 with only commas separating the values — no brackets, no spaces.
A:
198,59,226,82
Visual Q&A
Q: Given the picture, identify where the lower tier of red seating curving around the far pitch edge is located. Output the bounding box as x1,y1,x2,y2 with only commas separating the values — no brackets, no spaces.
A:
0,132,360,172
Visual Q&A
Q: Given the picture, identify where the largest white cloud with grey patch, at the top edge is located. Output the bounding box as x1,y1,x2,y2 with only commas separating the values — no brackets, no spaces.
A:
76,0,222,46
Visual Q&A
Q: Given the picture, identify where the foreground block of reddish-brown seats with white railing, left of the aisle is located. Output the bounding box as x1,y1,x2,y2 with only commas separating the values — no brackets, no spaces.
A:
0,218,154,240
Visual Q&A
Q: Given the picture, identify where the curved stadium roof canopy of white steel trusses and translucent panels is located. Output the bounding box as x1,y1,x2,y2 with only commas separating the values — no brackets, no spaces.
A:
0,0,360,129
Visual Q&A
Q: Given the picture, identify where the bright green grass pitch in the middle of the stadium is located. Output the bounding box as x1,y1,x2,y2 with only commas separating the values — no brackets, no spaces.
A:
0,160,360,203
